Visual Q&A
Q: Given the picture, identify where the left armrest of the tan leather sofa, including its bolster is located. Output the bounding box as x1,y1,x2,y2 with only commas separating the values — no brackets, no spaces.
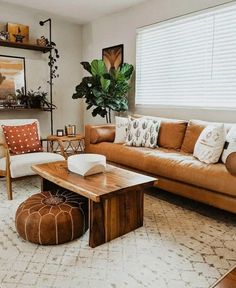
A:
85,124,116,149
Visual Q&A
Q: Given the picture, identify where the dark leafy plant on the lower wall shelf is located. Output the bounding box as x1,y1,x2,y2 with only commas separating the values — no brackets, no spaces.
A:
16,86,56,111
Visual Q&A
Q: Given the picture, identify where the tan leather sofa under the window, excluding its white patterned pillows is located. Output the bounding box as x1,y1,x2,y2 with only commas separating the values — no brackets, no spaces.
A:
85,118,236,213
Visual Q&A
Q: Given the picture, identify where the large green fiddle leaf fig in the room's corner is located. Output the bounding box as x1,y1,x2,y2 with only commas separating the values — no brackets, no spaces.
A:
72,59,134,123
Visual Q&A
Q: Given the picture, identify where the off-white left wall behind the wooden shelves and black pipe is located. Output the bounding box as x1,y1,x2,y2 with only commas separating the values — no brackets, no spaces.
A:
0,2,83,136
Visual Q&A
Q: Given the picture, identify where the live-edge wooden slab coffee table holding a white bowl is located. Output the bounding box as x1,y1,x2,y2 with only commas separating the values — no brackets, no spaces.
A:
32,161,157,248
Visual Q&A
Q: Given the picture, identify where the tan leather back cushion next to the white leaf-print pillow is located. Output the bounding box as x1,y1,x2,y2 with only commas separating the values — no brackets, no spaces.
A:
157,121,187,150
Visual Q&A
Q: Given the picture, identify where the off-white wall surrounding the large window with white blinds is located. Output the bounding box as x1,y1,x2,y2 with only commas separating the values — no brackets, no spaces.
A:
82,0,236,123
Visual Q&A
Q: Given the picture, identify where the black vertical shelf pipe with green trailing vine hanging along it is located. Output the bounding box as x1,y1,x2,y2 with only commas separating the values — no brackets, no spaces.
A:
39,18,59,134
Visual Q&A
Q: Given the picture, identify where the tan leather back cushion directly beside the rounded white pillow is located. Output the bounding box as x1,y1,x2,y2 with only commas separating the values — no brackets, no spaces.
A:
181,120,207,154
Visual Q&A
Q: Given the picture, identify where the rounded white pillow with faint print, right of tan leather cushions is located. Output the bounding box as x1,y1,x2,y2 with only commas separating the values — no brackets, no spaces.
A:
193,124,225,164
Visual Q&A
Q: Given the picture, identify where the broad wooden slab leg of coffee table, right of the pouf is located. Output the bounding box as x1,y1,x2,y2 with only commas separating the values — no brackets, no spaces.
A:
89,186,143,248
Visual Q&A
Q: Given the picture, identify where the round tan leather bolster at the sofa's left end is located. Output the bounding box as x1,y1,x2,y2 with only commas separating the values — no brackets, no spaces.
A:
90,125,115,144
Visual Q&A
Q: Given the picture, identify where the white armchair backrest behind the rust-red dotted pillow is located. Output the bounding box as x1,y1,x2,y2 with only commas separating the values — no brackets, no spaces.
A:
0,119,40,158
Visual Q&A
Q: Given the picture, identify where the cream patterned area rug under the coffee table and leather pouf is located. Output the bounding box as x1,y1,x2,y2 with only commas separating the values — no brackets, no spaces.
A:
0,177,236,288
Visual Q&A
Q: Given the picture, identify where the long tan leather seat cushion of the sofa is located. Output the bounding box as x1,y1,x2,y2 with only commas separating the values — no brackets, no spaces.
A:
86,142,236,196
